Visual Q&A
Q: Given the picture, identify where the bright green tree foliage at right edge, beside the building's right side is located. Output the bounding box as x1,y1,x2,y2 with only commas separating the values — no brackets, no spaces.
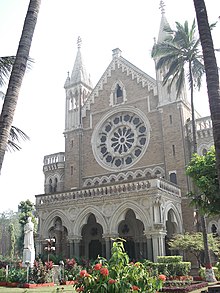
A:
186,147,220,215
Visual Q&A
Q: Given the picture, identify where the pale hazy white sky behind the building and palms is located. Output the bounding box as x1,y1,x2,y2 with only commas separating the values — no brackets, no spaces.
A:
0,0,220,212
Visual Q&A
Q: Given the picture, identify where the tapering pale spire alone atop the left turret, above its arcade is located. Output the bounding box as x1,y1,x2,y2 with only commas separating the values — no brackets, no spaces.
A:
70,37,92,87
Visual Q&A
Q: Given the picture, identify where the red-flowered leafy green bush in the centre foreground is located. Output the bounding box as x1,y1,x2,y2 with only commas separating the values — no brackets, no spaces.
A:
74,238,166,293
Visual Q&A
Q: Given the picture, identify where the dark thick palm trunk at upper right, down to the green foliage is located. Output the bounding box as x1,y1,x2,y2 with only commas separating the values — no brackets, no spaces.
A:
193,0,220,186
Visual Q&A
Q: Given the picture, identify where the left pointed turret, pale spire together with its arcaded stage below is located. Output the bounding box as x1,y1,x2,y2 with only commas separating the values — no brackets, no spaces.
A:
64,37,92,130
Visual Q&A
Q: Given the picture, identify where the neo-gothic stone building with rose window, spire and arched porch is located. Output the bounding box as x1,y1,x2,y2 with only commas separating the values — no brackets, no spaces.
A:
36,12,219,260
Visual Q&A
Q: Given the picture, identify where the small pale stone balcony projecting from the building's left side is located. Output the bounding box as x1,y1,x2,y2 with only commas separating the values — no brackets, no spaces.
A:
43,152,65,172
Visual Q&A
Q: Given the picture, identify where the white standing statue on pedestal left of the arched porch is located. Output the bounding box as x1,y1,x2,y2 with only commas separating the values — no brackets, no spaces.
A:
23,217,35,267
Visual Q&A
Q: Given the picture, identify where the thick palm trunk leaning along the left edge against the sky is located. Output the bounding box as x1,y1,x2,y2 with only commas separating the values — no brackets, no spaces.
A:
0,0,41,172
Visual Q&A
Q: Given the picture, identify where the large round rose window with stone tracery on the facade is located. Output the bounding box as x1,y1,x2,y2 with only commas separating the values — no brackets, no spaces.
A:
93,111,149,169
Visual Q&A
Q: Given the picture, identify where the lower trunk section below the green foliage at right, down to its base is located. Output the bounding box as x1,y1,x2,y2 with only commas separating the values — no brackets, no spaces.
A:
201,215,216,282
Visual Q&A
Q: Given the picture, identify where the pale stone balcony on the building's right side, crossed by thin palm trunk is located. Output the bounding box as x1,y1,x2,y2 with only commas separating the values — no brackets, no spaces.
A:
186,116,213,141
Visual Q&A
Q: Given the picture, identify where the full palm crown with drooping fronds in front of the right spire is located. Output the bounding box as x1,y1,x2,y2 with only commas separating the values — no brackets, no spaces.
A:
152,19,204,100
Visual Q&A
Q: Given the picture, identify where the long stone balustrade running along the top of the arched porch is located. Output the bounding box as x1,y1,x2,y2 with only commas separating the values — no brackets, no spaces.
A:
36,178,181,207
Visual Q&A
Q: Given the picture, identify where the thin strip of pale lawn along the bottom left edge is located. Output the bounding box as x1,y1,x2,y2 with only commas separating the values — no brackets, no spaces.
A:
0,285,76,293
